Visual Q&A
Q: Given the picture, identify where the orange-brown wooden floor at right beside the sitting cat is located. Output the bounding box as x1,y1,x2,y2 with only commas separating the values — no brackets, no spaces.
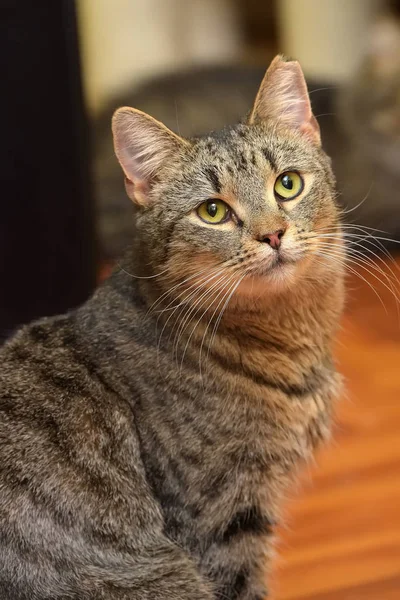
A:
272,257,400,600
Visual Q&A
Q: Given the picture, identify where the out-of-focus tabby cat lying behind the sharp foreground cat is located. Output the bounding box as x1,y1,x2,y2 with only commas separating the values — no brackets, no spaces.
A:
94,16,400,259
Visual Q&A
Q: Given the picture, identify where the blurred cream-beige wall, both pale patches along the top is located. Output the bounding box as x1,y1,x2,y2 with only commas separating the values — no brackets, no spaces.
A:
77,0,388,112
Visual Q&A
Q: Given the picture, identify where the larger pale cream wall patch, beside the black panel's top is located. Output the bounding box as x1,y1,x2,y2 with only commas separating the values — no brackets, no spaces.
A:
78,0,241,112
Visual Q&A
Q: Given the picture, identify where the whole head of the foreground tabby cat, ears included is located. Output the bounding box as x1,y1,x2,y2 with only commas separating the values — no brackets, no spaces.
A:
113,57,341,304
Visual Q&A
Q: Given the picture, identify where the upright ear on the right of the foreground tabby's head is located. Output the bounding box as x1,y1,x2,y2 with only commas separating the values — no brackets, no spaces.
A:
249,56,321,146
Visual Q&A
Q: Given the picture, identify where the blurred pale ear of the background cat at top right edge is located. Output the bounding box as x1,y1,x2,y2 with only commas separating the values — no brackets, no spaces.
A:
366,15,400,78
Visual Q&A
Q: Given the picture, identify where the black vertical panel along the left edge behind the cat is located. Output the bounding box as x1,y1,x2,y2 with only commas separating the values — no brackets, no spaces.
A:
0,0,95,339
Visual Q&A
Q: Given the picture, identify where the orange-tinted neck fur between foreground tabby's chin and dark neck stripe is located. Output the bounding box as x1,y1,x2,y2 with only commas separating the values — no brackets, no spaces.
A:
145,265,344,351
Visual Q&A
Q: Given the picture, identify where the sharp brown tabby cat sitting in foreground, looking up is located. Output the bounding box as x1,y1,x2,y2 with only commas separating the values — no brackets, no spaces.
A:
0,57,345,600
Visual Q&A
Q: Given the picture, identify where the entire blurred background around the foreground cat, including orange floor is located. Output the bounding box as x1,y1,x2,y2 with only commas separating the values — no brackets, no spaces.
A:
0,0,400,600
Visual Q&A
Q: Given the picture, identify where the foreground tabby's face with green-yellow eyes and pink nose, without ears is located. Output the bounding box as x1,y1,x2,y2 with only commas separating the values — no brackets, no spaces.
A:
140,125,337,296
